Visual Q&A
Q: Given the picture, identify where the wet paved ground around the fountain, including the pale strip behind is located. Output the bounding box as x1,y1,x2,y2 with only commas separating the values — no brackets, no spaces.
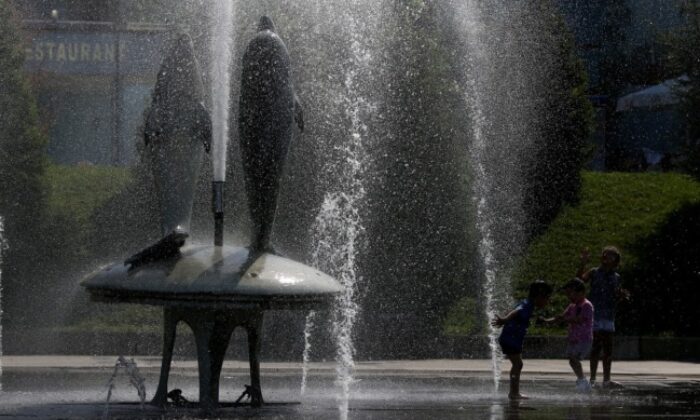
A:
0,356,700,419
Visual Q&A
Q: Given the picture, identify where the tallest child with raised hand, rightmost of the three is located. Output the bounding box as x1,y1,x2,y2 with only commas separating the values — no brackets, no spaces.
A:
577,246,629,388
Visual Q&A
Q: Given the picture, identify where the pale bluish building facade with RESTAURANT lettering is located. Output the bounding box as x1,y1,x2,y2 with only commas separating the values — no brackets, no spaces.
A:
16,1,168,166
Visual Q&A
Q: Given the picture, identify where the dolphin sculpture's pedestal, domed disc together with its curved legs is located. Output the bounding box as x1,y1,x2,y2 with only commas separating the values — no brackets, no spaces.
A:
81,245,341,409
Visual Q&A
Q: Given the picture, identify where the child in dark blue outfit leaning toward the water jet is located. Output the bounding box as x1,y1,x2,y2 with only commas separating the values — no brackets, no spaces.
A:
491,280,552,400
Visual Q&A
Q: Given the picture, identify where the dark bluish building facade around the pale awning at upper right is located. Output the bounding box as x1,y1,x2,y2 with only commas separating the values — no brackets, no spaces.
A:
559,0,685,170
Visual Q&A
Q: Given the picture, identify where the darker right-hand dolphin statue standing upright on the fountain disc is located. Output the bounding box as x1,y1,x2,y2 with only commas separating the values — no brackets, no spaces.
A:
238,16,304,255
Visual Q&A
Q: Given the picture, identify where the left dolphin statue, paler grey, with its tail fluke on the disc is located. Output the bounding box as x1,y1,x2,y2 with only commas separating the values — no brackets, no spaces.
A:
125,33,211,267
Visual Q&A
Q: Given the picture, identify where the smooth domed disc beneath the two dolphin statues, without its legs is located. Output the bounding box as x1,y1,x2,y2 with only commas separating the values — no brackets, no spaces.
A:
81,244,342,310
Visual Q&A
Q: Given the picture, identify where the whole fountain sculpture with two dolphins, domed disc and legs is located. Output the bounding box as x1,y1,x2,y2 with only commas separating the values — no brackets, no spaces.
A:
82,16,340,409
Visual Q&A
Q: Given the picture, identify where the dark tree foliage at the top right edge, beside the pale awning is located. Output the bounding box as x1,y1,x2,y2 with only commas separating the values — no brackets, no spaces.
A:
668,0,700,178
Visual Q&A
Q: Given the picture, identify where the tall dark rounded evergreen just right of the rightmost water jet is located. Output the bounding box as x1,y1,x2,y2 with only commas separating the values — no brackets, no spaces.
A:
523,0,593,234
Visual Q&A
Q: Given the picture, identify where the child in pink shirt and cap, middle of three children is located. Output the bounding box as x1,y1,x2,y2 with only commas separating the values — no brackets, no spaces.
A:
545,279,593,392
